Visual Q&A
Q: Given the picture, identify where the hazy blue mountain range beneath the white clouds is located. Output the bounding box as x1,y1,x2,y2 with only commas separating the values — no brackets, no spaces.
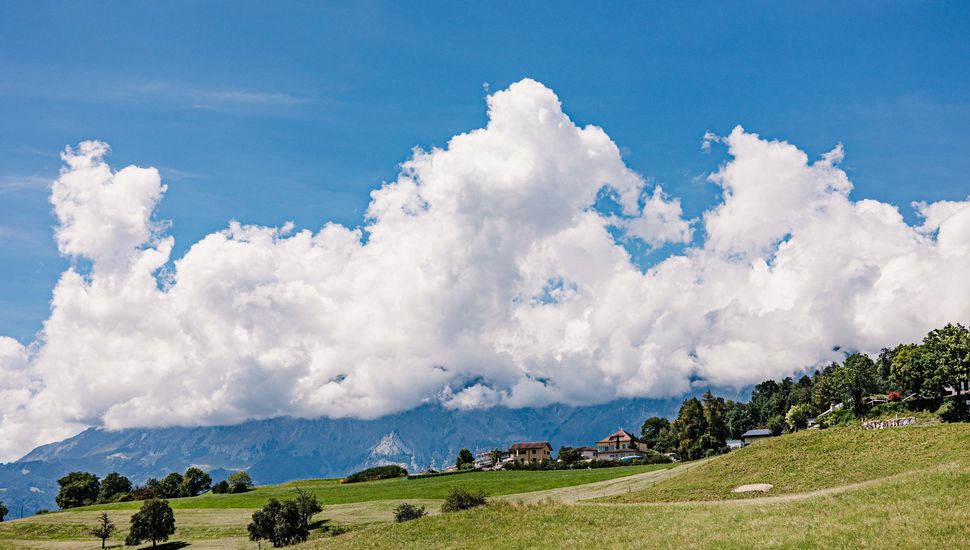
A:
0,399,681,518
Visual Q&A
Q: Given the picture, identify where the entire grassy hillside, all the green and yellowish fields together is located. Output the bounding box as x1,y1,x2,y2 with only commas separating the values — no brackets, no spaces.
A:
0,424,970,549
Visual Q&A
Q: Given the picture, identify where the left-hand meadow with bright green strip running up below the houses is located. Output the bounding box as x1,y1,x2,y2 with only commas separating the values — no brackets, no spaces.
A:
0,464,672,548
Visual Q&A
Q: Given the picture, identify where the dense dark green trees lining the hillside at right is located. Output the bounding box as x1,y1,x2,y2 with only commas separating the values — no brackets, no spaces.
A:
640,324,970,460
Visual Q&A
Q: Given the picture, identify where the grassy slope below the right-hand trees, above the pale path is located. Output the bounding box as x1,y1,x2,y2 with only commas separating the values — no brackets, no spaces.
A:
603,424,970,503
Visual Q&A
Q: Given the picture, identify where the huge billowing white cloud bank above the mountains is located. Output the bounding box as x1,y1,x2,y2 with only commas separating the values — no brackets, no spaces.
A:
0,80,970,459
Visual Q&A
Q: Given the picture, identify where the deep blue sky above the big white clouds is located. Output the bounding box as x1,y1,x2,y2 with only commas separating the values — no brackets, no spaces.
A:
0,2,970,343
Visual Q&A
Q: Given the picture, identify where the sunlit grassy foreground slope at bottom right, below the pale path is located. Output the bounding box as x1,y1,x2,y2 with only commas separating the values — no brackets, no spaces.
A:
305,461,970,549
